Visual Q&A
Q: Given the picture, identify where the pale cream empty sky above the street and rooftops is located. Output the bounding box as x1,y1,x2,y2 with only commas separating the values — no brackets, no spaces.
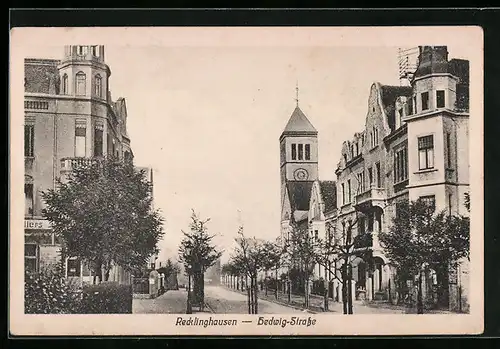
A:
22,41,467,260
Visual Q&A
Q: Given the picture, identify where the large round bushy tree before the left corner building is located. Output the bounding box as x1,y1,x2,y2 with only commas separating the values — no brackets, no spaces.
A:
42,158,163,283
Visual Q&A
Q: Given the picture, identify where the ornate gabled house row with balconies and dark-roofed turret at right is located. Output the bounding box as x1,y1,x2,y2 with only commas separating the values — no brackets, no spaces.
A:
332,46,469,311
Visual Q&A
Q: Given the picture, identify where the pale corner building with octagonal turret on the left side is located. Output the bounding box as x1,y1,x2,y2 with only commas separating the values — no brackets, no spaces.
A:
24,45,133,282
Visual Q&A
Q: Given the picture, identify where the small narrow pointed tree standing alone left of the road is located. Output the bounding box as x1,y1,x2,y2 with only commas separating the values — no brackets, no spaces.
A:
179,210,222,307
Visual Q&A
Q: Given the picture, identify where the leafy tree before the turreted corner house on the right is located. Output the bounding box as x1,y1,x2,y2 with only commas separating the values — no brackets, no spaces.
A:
379,199,470,314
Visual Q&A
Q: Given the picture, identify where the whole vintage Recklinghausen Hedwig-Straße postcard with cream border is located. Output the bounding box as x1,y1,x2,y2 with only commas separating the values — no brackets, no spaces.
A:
9,26,484,336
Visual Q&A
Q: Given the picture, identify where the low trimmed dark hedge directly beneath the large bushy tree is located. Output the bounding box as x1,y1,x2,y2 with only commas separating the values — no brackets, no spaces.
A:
80,282,133,314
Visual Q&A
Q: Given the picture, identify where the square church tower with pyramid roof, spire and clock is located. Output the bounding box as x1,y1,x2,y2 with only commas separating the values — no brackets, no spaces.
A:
279,89,318,234
